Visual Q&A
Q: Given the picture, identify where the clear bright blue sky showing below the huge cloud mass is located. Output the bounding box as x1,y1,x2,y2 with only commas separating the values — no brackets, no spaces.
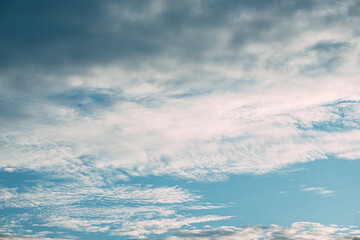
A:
0,156,360,239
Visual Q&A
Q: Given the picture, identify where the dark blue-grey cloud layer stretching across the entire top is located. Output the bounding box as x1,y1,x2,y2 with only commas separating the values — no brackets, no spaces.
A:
0,0,358,96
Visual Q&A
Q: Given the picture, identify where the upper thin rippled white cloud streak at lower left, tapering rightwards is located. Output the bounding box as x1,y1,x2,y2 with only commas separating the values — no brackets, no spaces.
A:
0,183,200,208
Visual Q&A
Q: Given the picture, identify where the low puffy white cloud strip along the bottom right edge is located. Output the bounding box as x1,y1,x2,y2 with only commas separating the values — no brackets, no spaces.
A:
161,222,359,240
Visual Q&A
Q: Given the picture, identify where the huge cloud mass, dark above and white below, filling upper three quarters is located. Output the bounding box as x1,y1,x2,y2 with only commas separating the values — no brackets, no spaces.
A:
0,1,360,181
